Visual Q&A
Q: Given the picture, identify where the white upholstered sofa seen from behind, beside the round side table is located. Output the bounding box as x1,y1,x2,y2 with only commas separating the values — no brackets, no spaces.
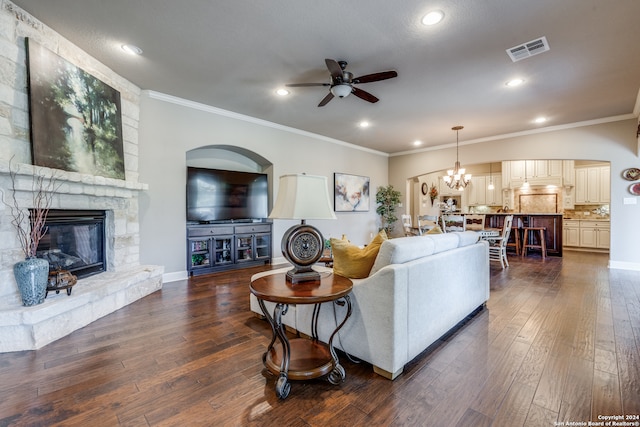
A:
251,231,489,379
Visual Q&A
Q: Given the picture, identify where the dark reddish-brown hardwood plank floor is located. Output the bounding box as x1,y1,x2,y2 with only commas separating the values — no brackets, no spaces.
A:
0,252,640,426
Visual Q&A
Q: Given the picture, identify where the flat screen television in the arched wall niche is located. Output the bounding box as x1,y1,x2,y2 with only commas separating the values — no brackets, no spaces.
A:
187,167,269,223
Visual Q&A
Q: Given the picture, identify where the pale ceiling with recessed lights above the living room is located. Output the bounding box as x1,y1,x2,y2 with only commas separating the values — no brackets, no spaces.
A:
13,0,640,153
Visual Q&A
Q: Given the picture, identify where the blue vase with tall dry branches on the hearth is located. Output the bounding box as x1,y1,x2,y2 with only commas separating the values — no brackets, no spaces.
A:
6,163,58,306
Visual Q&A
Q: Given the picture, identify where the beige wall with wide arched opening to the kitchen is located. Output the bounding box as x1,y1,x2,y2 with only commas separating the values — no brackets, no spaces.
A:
389,119,640,270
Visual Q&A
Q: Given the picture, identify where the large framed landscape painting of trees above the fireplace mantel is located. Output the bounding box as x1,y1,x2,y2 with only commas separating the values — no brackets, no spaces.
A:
26,39,125,179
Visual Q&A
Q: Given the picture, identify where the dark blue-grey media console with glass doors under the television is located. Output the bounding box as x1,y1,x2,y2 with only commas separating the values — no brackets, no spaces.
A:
187,222,272,276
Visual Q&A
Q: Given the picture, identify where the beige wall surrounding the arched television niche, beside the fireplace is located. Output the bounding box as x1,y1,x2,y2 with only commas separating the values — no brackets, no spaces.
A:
140,92,388,280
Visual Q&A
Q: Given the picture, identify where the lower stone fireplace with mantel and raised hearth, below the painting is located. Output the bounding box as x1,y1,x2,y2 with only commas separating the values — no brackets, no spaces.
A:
0,161,163,352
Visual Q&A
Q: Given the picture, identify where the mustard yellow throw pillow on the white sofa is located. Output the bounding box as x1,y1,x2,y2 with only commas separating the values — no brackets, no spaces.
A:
331,230,387,279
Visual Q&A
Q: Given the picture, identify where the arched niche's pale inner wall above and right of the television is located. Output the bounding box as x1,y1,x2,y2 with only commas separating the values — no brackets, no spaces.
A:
186,144,273,210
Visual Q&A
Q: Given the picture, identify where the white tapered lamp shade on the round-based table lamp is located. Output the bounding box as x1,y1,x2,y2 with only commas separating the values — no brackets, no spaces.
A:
269,174,336,220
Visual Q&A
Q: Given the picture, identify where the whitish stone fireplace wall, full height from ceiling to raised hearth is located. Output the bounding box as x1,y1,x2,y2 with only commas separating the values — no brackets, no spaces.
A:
0,0,163,352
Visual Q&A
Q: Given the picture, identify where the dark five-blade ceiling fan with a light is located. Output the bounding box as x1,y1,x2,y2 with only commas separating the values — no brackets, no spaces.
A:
286,59,398,107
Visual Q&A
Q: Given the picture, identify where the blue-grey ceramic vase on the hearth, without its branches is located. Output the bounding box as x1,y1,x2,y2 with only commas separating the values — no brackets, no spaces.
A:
13,257,49,307
